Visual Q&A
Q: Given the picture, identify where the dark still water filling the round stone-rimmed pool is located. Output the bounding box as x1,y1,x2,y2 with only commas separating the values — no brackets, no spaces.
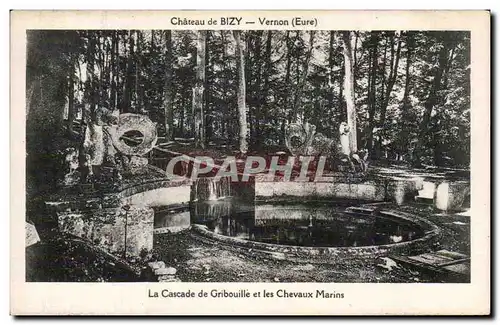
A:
156,201,425,247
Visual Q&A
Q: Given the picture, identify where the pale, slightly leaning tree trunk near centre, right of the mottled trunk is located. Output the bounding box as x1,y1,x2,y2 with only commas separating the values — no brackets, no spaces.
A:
233,30,248,154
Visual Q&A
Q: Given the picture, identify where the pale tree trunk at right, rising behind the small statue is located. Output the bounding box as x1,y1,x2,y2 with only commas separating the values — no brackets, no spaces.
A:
342,32,358,152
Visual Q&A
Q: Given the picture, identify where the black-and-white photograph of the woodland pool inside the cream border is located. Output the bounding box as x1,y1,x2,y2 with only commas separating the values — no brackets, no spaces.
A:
25,26,478,284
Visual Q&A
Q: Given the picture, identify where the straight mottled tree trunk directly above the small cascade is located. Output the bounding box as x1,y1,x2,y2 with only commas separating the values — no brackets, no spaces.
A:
193,31,206,148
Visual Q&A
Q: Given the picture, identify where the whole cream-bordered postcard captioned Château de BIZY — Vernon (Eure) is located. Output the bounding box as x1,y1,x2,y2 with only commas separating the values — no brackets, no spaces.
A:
10,10,491,315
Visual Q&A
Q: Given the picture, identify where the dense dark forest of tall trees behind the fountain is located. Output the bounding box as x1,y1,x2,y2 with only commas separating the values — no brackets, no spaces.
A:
26,30,471,194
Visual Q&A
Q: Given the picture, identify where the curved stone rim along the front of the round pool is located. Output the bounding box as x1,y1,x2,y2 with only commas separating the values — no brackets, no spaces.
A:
191,210,441,263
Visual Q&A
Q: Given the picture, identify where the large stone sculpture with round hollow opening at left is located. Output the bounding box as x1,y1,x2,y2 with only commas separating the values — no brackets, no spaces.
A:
63,107,157,186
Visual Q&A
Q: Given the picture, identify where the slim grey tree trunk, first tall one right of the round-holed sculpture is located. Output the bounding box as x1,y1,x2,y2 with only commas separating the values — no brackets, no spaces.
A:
163,30,174,142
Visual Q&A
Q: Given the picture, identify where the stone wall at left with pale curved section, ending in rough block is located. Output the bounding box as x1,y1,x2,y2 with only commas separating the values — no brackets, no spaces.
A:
45,179,191,257
